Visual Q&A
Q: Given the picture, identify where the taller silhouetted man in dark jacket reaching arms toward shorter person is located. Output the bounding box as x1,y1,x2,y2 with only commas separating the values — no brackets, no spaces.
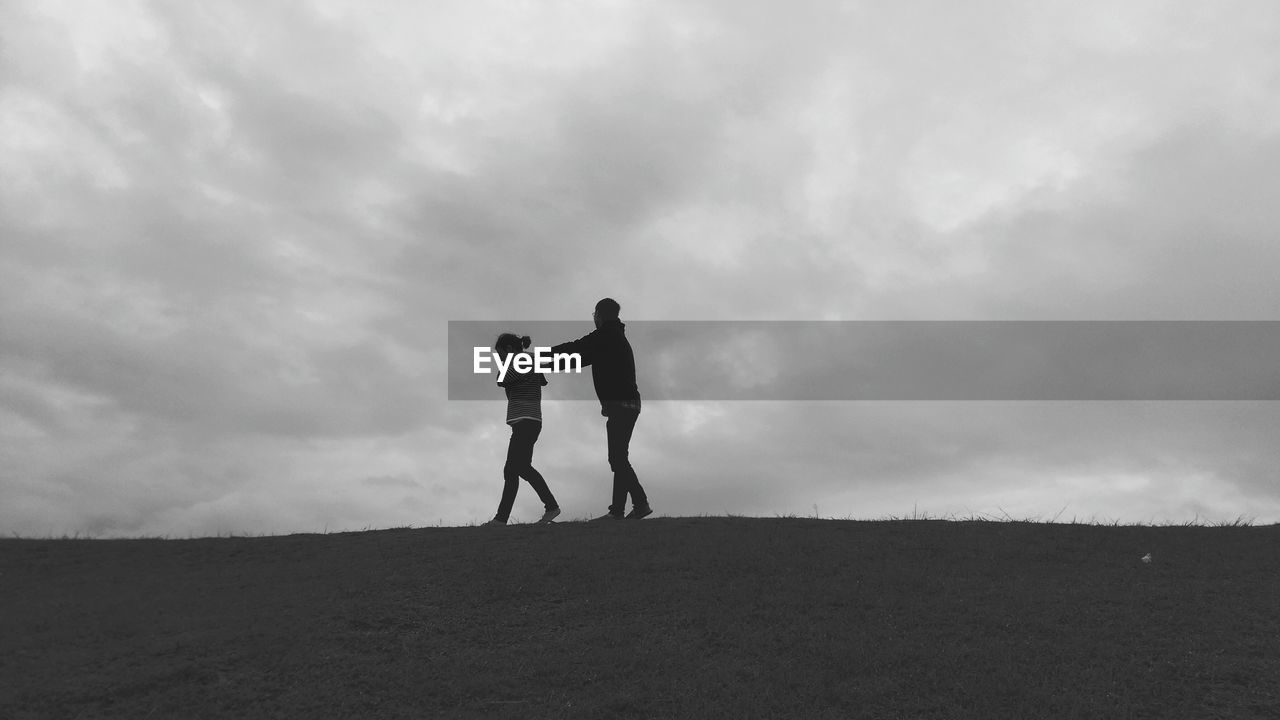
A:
552,297,653,520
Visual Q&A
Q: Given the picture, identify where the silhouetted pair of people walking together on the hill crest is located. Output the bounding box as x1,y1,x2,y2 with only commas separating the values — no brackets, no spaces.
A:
485,297,653,525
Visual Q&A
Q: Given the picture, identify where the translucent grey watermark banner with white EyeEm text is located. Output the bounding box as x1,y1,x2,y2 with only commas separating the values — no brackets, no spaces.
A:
448,320,1280,401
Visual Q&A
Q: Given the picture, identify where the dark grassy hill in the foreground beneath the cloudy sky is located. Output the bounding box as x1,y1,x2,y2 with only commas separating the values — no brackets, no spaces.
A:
0,518,1280,720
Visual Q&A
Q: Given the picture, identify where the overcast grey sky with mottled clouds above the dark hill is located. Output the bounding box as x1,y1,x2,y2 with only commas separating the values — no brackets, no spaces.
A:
0,0,1280,537
